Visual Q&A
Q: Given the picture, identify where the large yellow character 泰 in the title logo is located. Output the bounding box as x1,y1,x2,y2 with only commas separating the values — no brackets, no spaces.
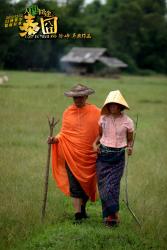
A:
19,14,40,37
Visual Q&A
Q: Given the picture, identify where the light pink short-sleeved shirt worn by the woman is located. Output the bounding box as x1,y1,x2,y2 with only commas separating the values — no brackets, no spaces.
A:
99,113,134,148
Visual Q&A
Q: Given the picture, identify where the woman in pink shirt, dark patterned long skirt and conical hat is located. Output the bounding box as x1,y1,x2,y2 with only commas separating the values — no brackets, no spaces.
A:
93,90,134,227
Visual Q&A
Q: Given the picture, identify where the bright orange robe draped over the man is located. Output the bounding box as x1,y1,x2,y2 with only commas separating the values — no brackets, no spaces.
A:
52,104,100,201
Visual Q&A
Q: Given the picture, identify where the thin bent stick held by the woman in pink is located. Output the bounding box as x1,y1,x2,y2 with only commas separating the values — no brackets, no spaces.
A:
124,115,141,228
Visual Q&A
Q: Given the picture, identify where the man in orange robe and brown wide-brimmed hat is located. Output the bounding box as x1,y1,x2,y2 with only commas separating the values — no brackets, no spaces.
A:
48,84,100,222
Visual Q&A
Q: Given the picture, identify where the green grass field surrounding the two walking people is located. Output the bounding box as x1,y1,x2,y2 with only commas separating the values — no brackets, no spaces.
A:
0,71,167,250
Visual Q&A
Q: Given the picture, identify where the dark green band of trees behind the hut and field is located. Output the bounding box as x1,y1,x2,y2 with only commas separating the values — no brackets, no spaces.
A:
0,0,167,73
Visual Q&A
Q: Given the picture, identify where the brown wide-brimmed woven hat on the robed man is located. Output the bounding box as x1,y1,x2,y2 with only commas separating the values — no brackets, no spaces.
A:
64,84,95,97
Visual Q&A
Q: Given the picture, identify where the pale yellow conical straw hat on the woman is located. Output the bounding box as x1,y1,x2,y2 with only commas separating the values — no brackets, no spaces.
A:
101,90,129,114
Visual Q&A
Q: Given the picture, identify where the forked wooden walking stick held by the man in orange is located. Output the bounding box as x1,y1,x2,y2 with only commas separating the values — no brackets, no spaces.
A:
41,117,58,222
